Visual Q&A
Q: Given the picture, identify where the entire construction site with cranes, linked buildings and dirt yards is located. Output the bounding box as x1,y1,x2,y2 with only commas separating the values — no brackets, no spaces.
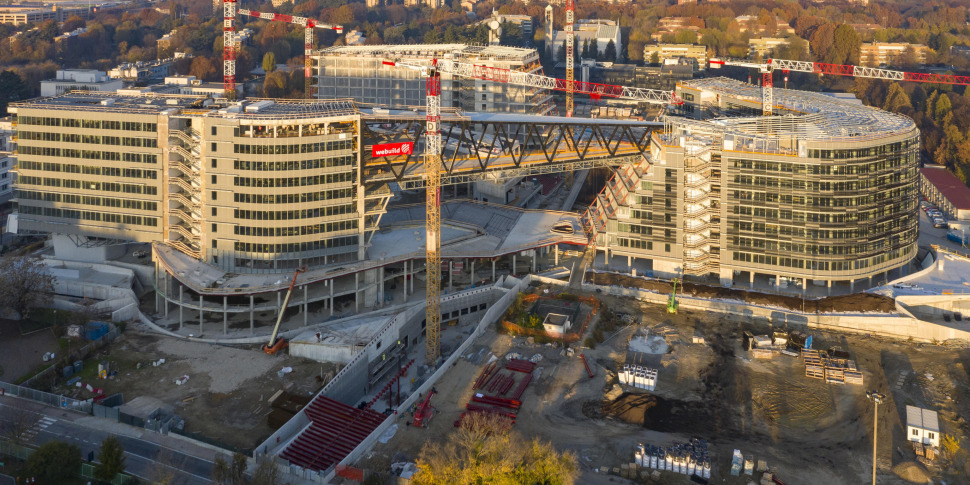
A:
10,1,970,484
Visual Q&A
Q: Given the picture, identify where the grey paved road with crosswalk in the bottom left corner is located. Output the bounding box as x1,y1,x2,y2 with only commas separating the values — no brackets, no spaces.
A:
0,397,215,485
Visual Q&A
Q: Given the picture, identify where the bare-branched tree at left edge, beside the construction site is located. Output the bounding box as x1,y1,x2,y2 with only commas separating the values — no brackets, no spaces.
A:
0,256,54,318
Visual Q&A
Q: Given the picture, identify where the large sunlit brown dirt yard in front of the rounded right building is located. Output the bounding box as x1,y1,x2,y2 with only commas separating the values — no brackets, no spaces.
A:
359,286,970,485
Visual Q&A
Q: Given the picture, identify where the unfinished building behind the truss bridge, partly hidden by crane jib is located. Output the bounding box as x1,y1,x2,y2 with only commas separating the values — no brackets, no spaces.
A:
314,44,553,114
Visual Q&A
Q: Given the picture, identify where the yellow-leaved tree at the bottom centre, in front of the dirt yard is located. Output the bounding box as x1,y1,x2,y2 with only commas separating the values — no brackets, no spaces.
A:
413,413,578,485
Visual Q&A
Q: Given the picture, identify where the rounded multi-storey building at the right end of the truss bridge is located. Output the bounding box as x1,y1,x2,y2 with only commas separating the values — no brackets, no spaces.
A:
587,78,919,288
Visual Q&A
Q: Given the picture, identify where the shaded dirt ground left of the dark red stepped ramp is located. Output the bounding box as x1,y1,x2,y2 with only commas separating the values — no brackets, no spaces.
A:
54,331,336,451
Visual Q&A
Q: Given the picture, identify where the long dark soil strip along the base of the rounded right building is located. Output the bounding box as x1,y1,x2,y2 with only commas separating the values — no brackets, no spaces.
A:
586,272,896,313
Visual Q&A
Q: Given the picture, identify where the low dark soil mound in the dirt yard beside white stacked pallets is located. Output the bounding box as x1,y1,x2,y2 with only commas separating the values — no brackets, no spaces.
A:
600,393,712,433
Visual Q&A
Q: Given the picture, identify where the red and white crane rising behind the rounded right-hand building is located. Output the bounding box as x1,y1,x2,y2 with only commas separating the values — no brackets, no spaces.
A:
708,59,970,116
